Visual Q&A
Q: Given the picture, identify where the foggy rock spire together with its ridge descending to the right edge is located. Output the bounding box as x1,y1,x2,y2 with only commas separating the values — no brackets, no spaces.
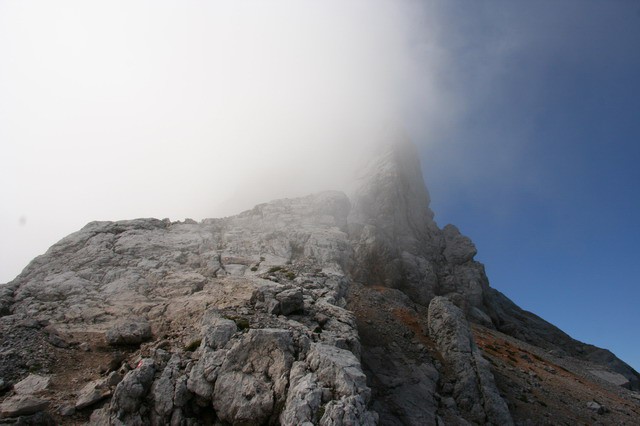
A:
349,138,640,389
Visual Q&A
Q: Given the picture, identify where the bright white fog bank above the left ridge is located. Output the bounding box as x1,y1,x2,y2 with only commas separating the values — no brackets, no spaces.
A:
0,1,451,282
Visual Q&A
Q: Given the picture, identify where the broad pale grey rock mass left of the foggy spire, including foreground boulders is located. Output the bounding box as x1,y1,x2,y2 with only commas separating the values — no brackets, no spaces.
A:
0,192,377,425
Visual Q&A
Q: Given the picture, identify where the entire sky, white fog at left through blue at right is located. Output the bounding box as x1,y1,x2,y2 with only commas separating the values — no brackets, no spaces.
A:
0,0,640,370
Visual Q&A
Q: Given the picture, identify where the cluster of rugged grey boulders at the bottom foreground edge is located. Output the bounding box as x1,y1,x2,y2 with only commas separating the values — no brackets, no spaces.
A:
102,302,377,425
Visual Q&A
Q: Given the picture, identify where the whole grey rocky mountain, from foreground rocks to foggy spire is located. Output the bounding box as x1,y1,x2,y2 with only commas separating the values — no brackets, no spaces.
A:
0,137,640,426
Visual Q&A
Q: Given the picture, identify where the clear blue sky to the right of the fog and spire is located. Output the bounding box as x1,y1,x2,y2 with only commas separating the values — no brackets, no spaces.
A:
417,1,640,370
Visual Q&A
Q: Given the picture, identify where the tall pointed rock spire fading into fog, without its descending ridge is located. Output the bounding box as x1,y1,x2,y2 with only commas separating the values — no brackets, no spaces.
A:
349,132,444,303
